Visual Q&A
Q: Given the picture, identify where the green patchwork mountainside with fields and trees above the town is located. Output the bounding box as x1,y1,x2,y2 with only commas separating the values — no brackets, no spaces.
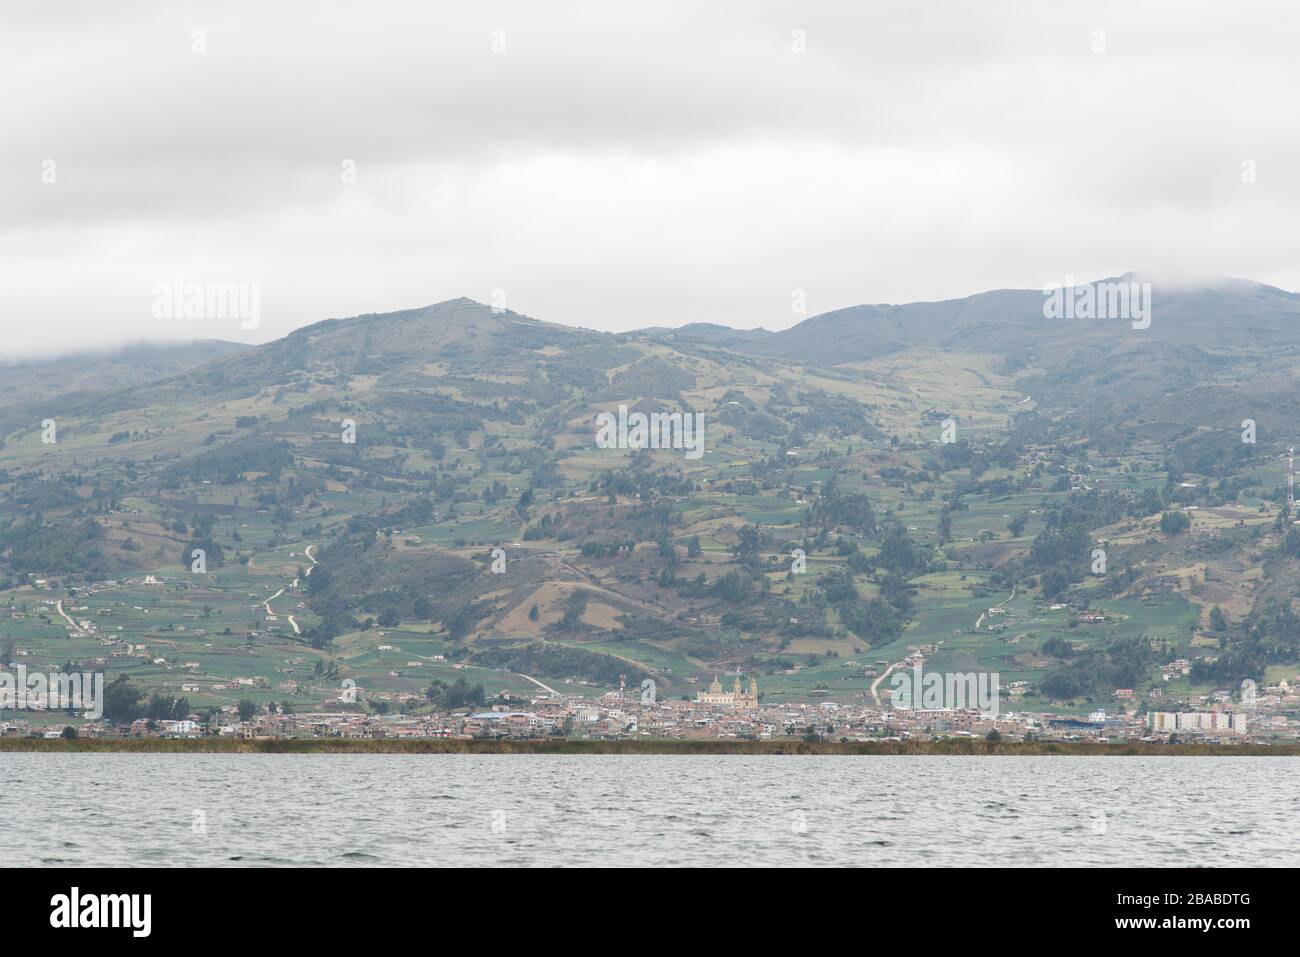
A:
0,277,1300,709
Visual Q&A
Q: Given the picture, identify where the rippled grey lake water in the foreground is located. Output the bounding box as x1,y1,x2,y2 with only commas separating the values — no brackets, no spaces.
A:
10,753,1300,867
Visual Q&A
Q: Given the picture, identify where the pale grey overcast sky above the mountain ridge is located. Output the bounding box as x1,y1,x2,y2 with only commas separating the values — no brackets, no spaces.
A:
0,0,1300,358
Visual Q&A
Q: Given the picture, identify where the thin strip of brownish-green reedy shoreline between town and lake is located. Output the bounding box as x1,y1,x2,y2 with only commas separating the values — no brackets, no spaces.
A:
0,737,1300,757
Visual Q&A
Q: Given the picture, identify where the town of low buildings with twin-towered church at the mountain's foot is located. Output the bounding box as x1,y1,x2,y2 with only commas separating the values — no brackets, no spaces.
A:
0,658,1300,744
